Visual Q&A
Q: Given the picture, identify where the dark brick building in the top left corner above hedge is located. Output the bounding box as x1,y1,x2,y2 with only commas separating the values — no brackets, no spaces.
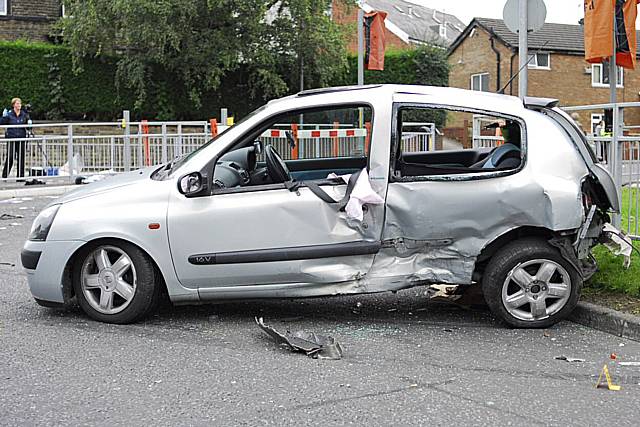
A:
0,0,62,41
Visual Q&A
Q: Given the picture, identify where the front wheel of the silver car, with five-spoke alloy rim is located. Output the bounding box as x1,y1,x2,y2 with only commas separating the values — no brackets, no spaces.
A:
73,242,159,324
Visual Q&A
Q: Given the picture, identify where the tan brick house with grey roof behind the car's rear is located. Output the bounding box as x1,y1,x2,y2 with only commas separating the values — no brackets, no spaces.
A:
448,18,640,131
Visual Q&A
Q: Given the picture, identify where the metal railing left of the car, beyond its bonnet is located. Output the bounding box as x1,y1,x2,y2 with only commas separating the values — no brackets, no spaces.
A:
0,121,212,184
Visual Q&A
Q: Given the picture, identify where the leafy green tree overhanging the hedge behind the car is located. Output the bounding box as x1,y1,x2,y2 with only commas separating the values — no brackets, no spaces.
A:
60,0,346,115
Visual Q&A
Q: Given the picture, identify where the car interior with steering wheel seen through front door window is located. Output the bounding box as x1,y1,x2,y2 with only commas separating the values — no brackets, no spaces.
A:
213,106,371,189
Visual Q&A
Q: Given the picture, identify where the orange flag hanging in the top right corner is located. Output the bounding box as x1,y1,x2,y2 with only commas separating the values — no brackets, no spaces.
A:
584,0,640,69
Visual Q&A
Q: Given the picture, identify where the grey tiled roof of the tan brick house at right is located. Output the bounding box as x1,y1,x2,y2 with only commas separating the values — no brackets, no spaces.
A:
449,18,640,55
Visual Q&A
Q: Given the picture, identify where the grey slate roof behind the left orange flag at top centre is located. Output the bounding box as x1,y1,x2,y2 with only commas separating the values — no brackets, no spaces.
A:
362,0,465,46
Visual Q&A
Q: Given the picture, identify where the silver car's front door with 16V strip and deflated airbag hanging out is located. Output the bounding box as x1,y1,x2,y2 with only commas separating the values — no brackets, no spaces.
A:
168,103,388,289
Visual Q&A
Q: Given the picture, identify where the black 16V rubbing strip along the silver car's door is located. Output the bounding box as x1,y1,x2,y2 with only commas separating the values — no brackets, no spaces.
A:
188,241,382,265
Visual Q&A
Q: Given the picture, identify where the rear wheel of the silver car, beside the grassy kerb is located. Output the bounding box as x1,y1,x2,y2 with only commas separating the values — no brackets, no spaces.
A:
482,239,582,328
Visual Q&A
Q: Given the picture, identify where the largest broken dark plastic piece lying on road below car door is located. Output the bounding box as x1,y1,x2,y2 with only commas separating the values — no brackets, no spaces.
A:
255,317,342,360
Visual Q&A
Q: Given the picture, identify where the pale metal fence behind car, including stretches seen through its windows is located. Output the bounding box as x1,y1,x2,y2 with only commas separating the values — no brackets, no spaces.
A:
0,121,435,187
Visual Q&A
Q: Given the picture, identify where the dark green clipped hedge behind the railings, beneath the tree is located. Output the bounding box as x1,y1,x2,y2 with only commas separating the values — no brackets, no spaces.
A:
0,41,448,123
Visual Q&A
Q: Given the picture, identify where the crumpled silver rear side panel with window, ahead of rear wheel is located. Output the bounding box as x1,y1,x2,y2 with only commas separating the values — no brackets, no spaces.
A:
370,98,532,284
